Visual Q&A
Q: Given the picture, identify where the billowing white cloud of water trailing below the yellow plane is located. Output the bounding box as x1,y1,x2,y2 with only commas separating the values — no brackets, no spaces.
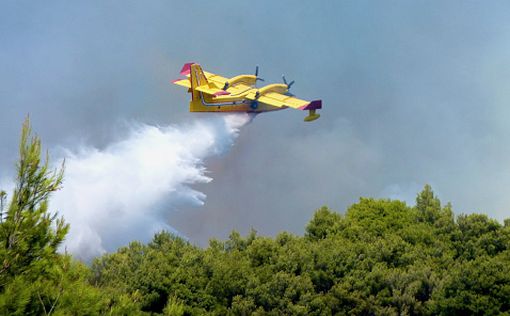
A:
50,114,251,259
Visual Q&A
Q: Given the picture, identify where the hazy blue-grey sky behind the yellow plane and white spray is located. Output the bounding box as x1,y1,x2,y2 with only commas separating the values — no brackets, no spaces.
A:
0,1,510,244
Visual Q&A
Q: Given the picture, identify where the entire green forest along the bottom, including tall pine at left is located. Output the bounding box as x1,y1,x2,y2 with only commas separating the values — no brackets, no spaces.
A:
0,121,510,315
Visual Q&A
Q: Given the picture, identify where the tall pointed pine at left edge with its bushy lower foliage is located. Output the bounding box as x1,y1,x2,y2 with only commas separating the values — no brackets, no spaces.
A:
0,119,105,315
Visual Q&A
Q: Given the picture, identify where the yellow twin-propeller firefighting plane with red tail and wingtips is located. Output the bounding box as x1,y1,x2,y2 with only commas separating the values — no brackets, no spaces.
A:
173,63,322,122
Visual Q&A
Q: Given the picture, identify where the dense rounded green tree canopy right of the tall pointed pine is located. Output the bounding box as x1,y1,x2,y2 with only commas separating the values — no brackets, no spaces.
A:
93,186,510,315
